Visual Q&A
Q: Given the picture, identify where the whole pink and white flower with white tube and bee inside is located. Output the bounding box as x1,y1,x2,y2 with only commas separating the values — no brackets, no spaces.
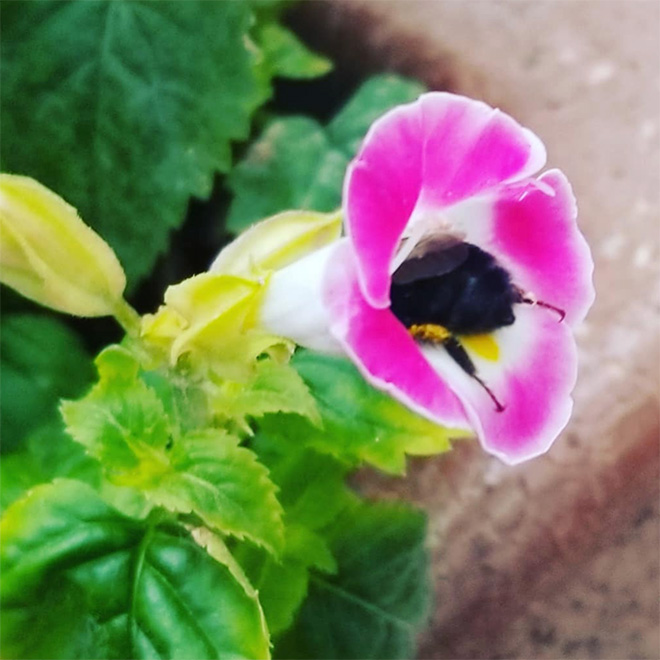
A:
263,93,594,464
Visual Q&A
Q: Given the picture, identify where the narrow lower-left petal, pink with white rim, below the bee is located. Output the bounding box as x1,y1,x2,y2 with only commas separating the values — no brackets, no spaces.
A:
324,245,470,429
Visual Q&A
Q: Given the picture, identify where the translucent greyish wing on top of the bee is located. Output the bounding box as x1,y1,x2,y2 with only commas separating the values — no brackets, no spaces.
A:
392,236,469,284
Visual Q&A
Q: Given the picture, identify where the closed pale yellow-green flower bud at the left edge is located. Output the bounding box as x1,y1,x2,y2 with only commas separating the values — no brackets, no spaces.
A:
0,174,126,316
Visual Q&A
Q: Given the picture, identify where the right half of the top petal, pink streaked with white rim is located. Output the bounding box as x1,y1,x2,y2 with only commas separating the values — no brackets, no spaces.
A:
419,93,546,211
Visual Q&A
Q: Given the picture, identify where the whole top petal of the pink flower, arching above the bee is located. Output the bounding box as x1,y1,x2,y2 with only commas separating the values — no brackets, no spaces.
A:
344,92,545,308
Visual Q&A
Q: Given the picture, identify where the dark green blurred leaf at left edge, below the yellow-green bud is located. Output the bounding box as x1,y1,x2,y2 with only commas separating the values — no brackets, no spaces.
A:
0,314,94,452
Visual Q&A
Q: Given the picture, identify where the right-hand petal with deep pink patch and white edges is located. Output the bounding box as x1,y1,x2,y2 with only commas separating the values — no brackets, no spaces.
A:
447,170,595,325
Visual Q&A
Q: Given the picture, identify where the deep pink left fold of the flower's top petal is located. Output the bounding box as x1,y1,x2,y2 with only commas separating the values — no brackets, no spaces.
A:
344,103,424,308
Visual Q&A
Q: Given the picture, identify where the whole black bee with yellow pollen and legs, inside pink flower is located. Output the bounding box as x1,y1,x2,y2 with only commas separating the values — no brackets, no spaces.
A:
390,237,564,412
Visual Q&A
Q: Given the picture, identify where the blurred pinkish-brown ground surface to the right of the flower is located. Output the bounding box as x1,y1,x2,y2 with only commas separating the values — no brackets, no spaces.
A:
289,0,660,659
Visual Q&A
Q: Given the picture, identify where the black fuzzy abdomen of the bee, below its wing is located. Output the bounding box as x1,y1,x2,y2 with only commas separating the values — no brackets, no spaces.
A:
390,244,520,335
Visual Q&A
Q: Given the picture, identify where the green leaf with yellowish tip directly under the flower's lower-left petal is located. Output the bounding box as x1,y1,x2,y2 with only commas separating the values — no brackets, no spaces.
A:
260,351,466,474
